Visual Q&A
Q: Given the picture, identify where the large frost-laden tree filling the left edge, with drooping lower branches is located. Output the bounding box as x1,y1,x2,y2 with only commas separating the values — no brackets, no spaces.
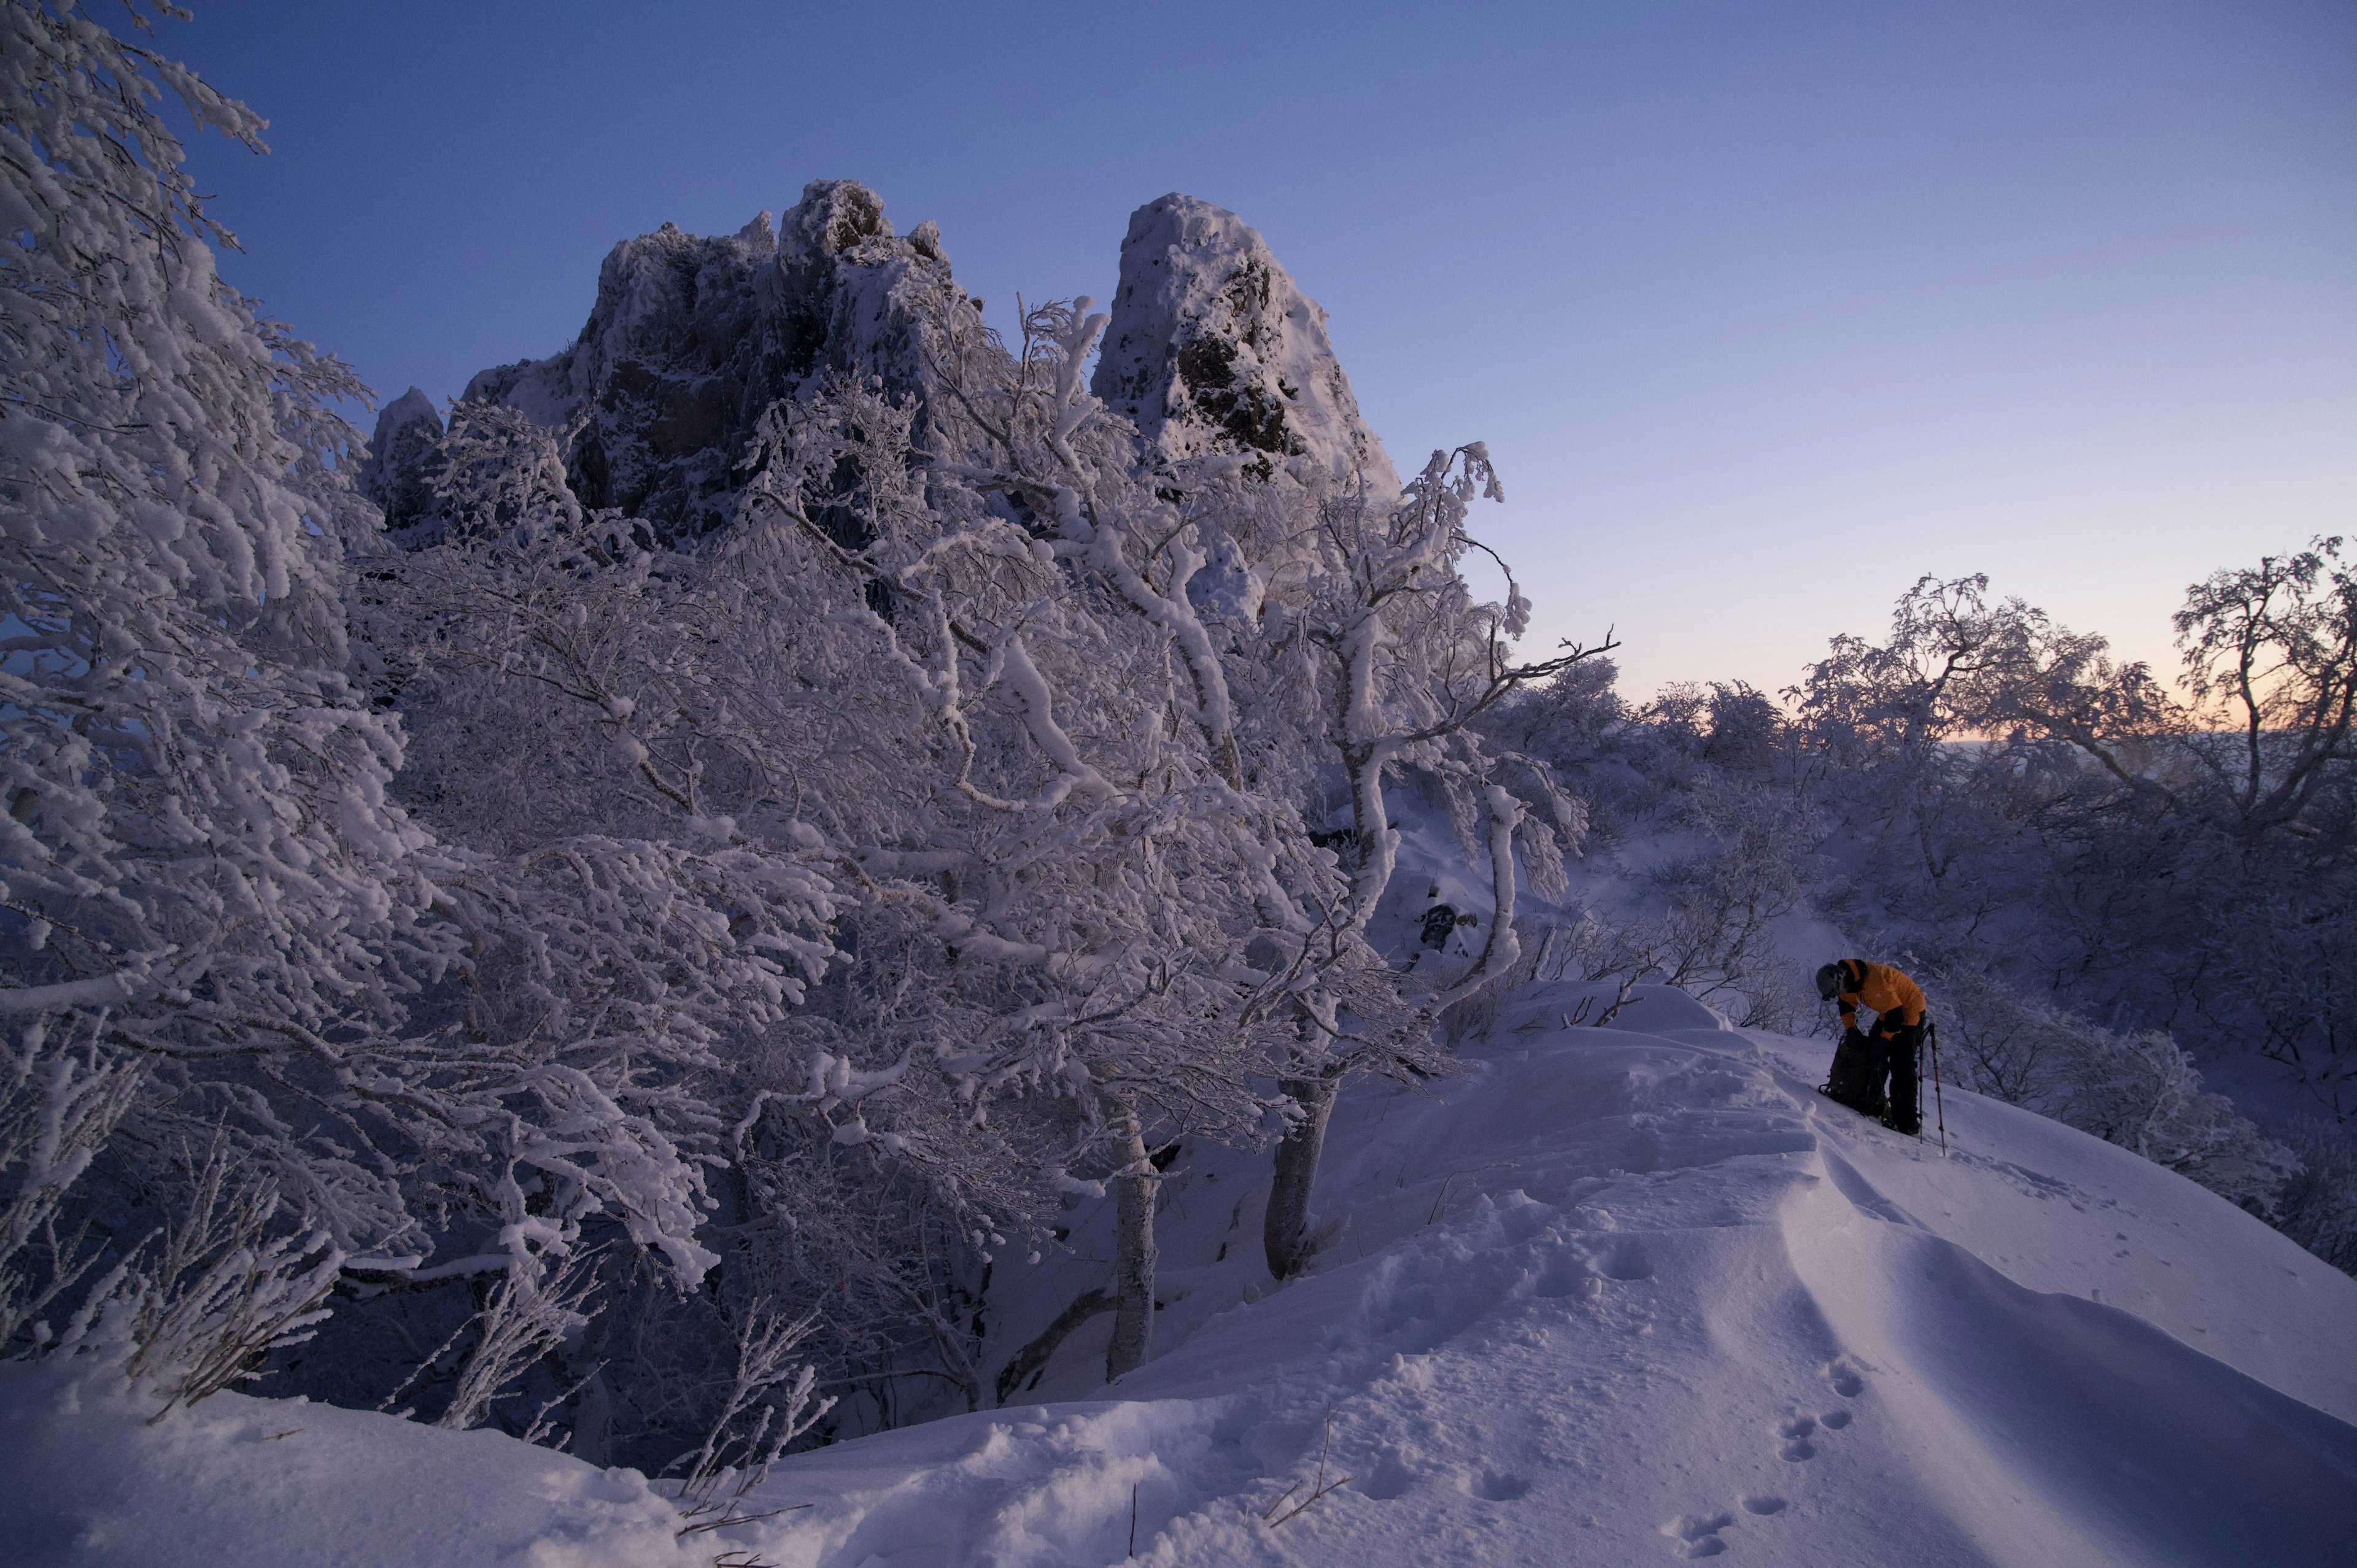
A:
0,0,830,1434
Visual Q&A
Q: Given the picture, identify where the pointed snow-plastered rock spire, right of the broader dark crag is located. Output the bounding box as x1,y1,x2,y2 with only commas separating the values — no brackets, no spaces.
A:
1094,193,1400,498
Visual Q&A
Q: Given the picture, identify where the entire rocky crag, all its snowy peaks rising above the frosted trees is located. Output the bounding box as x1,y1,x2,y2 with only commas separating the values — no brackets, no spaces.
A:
361,179,1398,557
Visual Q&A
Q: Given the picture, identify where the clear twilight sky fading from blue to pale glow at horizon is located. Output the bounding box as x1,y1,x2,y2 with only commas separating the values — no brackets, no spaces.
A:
171,0,2357,698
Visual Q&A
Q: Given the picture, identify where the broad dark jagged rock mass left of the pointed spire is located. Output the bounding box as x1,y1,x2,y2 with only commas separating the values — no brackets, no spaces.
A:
464,179,973,543
